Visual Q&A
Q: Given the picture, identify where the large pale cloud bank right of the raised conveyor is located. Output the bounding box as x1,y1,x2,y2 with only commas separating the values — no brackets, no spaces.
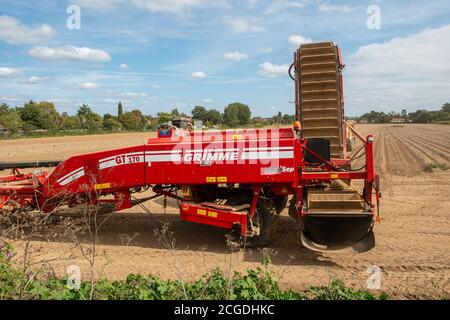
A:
344,25,450,114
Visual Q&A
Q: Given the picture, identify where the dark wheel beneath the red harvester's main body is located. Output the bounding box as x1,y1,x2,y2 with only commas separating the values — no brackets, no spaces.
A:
245,199,278,247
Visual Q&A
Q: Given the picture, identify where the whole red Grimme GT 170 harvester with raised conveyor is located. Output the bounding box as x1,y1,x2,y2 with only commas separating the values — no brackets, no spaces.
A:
0,42,379,252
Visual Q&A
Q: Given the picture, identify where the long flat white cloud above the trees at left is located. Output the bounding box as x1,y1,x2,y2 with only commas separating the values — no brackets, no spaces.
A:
28,46,111,62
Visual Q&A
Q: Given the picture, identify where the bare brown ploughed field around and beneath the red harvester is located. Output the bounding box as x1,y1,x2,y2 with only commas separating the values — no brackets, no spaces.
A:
0,125,450,298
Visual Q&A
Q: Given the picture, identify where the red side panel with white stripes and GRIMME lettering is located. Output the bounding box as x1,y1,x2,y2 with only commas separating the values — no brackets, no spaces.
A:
146,129,295,184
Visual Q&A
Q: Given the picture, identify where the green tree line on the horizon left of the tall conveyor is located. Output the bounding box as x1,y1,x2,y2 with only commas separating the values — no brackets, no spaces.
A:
0,101,294,134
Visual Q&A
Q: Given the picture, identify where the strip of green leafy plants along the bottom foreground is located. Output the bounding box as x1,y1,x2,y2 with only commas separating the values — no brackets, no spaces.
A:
0,246,387,300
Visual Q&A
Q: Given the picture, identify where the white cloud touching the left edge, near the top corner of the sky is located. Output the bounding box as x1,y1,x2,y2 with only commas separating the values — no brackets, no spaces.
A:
0,15,55,44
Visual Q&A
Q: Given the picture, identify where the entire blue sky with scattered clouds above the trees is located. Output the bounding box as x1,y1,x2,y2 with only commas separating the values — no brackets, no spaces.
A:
0,0,450,116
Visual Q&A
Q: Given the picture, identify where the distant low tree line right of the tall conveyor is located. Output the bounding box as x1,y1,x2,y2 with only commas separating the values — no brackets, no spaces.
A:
355,103,450,123
